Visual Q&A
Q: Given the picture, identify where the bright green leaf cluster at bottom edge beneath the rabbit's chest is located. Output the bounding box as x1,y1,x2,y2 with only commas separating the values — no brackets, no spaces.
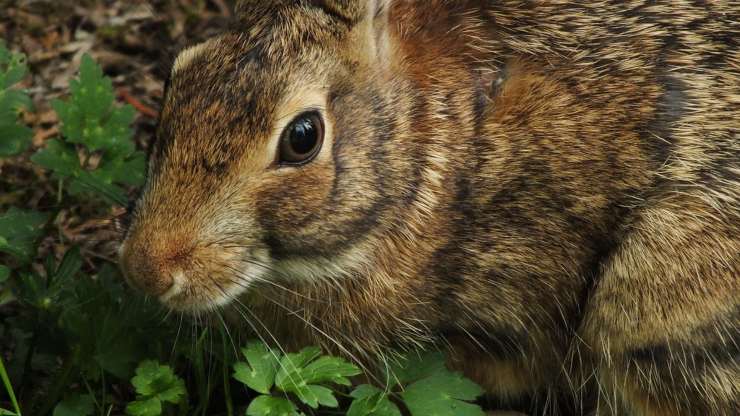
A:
233,342,484,416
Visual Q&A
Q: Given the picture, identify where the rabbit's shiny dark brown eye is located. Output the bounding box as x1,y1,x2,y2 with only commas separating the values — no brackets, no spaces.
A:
278,111,324,165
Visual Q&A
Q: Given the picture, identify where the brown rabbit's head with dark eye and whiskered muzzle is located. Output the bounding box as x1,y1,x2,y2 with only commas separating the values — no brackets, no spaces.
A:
120,0,424,310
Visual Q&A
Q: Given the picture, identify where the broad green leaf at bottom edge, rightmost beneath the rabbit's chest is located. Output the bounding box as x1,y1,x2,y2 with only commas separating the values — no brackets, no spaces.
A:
401,371,485,416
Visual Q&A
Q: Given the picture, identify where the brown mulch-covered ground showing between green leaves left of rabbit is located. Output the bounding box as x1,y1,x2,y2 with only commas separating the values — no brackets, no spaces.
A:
0,0,233,267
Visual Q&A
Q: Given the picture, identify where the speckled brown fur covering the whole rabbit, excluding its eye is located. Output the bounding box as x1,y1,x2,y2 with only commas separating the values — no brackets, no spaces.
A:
121,0,740,416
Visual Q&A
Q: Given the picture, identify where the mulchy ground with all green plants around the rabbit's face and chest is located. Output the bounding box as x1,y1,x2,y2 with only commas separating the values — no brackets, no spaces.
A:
0,0,494,416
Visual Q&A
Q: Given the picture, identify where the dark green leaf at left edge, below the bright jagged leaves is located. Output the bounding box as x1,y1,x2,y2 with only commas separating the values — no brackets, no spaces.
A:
0,207,49,263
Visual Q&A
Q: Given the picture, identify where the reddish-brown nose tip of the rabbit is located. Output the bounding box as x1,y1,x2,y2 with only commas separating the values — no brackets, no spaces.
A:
120,241,190,297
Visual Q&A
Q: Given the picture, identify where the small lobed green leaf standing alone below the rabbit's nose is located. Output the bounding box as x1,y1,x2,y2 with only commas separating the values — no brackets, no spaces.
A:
131,361,186,403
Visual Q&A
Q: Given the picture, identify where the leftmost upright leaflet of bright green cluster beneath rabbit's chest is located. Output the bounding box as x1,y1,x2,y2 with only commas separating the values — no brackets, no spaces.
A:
234,342,278,394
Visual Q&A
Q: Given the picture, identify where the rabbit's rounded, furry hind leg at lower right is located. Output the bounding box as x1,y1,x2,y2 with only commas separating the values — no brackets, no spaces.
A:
581,194,740,416
